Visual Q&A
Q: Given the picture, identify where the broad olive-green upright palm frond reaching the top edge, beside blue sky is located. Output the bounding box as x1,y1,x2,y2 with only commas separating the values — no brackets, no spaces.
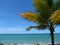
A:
34,0,50,20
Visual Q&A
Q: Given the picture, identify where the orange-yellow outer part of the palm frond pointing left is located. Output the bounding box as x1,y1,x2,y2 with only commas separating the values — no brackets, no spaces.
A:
21,12,38,22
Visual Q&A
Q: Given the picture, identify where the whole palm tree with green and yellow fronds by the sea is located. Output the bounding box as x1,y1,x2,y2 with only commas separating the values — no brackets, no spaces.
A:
21,0,60,45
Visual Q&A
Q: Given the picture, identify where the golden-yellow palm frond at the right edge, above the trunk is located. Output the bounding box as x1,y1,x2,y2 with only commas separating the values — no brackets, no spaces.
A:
50,10,60,23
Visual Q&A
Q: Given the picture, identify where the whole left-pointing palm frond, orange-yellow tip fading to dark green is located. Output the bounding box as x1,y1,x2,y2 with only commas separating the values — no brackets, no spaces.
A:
21,12,46,24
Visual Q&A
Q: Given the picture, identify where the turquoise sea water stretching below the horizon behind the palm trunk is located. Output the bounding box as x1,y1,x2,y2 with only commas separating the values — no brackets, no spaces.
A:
0,34,60,43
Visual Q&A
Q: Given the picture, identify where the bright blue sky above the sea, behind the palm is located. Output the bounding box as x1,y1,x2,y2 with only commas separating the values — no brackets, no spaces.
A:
0,0,60,34
